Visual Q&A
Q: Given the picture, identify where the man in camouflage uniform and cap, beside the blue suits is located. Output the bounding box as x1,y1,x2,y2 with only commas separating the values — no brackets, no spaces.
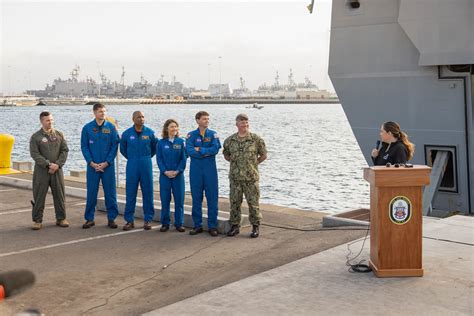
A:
223,114,267,238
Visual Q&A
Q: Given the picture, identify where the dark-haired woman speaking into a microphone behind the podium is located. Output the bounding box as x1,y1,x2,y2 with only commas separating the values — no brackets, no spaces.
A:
372,122,415,166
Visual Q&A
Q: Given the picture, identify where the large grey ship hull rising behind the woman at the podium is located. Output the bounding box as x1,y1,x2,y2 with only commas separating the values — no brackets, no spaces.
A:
329,0,474,215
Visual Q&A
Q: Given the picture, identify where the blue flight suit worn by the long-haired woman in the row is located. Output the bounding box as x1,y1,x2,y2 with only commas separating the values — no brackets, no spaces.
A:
156,137,187,227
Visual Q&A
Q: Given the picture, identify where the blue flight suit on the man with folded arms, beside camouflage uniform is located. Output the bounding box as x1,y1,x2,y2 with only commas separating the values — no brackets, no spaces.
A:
186,128,221,229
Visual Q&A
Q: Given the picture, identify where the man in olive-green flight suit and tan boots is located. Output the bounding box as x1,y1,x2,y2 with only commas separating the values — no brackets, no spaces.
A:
30,112,69,230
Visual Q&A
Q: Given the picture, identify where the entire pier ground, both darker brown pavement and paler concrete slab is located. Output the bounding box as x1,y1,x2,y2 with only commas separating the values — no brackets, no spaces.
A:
0,173,474,315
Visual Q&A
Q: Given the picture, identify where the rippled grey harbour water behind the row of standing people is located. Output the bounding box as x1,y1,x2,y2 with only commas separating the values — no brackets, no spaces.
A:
0,104,370,213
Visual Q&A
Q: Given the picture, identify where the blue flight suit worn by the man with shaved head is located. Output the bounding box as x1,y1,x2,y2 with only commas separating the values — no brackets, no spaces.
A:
120,126,157,223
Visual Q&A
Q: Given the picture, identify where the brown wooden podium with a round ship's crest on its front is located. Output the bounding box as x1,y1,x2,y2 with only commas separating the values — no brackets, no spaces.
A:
364,165,431,278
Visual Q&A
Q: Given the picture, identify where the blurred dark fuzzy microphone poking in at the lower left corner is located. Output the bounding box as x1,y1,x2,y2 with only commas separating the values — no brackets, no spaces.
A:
0,270,35,301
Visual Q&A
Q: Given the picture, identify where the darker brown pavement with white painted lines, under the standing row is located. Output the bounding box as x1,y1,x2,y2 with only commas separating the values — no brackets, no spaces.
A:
0,173,365,315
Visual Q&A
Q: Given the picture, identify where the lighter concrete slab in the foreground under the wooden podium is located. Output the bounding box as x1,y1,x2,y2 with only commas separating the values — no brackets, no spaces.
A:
146,216,474,316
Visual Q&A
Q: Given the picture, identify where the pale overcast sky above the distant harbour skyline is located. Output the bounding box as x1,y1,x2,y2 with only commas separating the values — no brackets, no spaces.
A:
0,0,334,94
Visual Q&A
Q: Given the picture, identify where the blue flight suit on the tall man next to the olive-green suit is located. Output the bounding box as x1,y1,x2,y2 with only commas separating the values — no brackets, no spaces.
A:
81,120,119,221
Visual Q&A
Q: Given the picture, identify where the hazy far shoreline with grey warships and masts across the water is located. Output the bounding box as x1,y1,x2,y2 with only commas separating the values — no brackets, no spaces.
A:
21,65,337,103
